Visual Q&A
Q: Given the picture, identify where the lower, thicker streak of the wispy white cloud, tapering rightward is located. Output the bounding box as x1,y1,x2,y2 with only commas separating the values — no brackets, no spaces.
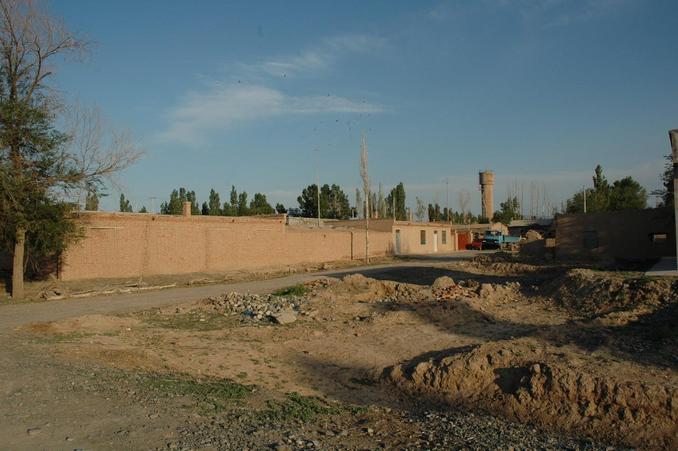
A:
156,83,384,145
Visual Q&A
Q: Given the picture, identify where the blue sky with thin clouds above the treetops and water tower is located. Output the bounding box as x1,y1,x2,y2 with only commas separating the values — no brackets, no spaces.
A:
51,0,678,212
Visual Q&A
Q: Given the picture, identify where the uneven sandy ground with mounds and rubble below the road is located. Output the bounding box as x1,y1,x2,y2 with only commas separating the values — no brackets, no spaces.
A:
0,258,678,449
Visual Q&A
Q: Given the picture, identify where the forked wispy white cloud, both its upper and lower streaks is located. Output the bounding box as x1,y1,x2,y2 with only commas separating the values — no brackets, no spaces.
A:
155,34,386,145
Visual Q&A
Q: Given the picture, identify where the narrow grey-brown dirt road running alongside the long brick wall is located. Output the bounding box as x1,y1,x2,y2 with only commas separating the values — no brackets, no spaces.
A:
0,252,476,331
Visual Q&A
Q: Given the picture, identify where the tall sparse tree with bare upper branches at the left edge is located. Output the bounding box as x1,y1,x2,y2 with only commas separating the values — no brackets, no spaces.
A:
0,0,147,299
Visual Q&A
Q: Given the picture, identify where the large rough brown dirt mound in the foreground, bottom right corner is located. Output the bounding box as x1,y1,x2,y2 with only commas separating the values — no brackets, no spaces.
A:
382,339,678,449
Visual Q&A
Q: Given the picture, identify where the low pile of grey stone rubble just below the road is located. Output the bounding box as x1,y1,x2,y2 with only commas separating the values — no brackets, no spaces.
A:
202,293,308,324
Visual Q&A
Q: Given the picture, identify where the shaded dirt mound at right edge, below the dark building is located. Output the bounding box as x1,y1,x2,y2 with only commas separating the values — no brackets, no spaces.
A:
541,269,678,316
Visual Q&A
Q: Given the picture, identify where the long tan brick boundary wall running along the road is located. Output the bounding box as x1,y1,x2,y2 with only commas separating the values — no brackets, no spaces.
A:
58,212,393,280
